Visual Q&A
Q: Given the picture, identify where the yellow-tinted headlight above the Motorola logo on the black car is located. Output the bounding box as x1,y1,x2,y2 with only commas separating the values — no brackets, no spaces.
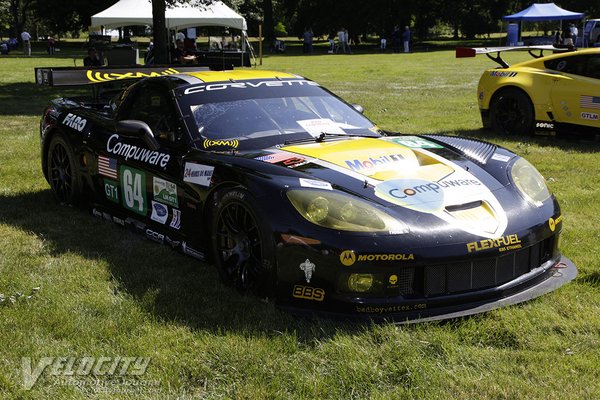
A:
287,189,408,233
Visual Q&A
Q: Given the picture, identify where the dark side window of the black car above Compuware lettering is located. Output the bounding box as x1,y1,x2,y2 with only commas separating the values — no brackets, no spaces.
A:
120,85,179,144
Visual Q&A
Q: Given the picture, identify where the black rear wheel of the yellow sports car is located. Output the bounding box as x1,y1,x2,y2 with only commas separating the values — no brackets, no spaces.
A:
490,88,535,136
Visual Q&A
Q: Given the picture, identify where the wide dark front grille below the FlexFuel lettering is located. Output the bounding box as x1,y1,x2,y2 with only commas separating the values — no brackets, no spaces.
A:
422,237,554,297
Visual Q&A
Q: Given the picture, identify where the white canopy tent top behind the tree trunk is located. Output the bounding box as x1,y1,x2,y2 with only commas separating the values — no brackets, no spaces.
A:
92,0,247,31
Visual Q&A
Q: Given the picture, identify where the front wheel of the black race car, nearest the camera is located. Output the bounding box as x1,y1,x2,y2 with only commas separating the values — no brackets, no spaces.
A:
212,189,275,297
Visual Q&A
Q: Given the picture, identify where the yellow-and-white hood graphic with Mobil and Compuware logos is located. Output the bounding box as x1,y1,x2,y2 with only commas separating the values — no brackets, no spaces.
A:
253,136,507,238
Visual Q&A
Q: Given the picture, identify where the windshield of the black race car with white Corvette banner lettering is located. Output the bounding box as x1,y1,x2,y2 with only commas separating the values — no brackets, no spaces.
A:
180,80,378,147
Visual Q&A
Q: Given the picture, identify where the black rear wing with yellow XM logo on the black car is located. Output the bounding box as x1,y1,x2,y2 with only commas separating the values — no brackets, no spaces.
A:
35,65,209,86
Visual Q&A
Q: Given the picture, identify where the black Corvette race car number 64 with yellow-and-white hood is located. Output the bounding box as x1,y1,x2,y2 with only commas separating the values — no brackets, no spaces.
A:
37,65,577,321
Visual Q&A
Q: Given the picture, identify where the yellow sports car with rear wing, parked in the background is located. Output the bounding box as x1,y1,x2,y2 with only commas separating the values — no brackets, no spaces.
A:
456,46,600,135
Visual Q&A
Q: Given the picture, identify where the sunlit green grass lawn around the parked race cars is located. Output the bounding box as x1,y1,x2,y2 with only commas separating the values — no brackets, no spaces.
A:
0,45,600,399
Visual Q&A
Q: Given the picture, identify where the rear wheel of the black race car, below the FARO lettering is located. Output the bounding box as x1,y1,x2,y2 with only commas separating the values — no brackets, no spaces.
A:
47,134,81,205
